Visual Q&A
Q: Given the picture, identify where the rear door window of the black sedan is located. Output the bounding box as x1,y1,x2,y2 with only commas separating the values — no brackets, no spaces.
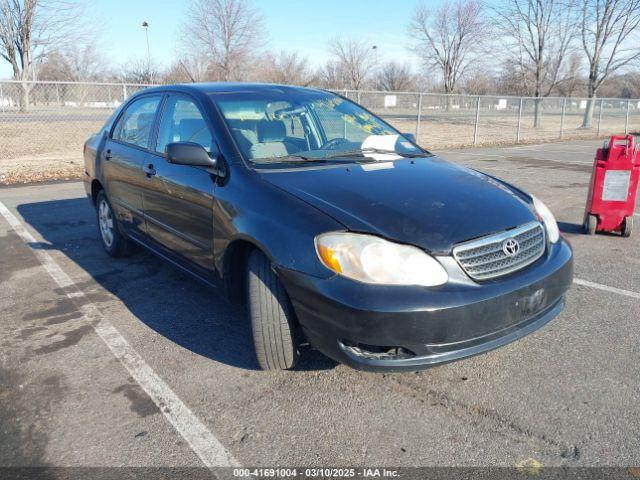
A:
113,96,161,148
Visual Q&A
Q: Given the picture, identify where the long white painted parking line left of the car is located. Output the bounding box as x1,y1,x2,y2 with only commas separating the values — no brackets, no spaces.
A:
0,202,239,467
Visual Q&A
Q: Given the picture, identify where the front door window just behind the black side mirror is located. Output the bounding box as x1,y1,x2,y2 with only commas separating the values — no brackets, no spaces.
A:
156,96,214,153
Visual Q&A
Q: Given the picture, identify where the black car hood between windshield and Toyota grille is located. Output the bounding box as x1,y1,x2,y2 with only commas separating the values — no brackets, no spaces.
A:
261,157,535,254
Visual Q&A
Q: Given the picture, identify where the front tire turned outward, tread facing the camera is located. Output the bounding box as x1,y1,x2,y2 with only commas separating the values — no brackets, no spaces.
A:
247,250,299,370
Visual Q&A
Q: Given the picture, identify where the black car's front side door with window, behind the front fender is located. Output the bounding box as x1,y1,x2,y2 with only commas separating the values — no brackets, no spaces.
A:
143,94,217,273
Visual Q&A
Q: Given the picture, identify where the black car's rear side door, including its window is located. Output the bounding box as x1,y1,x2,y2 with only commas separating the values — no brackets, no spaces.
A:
101,95,162,236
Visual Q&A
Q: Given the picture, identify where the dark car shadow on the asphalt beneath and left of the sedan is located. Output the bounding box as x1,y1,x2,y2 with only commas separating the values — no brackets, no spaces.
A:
17,198,337,371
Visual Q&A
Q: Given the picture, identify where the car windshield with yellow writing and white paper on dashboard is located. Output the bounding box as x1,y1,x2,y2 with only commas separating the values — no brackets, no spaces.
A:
215,90,429,167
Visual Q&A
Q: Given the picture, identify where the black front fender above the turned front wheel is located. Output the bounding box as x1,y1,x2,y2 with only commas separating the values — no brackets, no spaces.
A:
213,165,344,278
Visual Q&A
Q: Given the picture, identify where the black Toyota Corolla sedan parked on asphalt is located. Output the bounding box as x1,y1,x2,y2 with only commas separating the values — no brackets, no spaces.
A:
84,84,573,370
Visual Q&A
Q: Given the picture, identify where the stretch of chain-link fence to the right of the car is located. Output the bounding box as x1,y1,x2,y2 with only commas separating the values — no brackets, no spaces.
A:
340,90,640,150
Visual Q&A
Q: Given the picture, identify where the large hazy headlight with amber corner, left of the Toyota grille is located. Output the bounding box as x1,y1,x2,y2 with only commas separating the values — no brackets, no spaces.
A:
316,232,448,287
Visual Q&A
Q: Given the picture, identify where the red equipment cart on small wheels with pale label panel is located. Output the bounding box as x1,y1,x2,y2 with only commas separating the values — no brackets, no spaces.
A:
584,135,640,237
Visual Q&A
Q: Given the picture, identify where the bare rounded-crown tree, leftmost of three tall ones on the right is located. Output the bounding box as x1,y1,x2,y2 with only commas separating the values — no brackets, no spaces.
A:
410,0,487,93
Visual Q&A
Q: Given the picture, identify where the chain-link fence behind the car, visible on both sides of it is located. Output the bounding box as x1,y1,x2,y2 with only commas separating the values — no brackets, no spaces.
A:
0,81,640,183
